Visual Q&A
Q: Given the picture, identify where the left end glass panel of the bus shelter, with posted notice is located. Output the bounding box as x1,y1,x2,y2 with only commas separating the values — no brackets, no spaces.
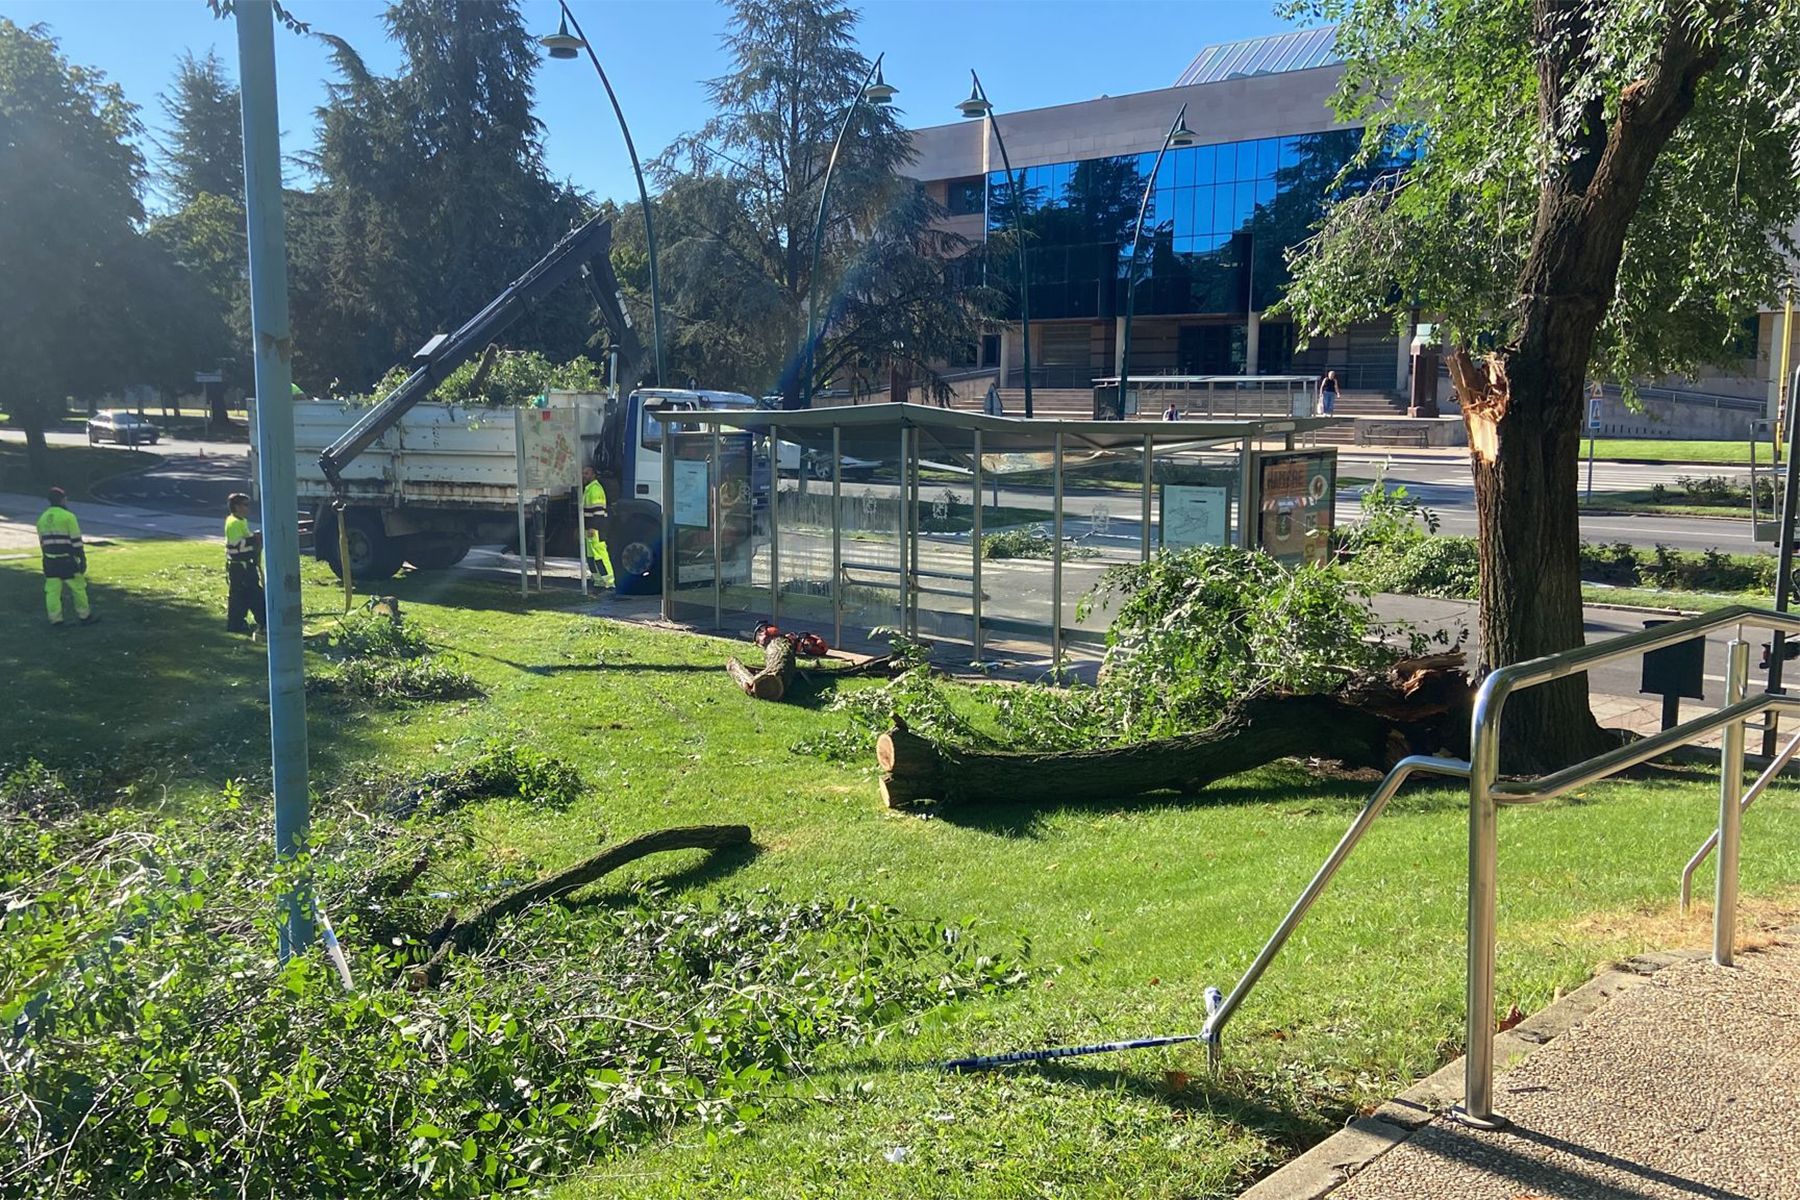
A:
662,430,769,628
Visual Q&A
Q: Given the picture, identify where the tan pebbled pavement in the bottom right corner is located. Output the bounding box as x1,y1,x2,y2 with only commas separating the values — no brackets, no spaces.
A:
1317,937,1800,1200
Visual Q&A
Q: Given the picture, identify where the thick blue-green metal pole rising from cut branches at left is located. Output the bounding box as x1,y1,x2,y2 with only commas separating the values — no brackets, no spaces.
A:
236,0,313,959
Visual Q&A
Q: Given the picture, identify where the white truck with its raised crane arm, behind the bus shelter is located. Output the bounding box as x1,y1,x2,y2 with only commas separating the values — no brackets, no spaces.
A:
259,216,769,594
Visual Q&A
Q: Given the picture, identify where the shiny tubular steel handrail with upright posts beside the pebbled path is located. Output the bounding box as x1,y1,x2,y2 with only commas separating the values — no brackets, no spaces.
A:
1458,604,1800,1128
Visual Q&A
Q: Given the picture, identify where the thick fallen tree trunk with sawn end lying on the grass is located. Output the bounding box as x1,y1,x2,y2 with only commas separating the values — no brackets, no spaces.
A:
875,651,1472,808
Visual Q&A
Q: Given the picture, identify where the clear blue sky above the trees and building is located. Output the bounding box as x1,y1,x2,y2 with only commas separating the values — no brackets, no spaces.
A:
0,0,1287,211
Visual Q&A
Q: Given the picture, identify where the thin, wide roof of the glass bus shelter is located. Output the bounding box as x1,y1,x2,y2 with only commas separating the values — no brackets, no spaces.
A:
653,405,1339,464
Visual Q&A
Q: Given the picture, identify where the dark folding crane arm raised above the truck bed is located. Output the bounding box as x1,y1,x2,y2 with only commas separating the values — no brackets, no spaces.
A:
319,216,644,495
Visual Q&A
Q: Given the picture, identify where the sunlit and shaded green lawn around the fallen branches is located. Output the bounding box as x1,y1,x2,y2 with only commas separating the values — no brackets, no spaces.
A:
0,543,1800,1200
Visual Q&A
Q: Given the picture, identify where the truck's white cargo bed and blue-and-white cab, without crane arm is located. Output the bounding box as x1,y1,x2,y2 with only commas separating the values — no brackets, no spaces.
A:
275,389,763,594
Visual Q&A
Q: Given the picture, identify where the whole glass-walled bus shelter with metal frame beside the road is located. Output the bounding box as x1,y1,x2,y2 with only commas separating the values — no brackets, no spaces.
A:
662,405,1336,664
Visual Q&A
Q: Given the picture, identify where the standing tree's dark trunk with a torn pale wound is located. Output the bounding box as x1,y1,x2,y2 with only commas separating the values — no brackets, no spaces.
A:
1451,0,1717,770
